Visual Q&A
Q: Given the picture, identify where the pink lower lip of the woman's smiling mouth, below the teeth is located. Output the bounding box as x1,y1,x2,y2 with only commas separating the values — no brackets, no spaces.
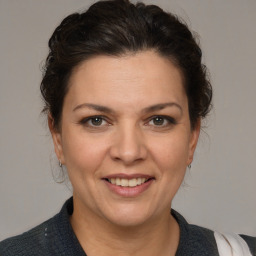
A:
104,179,154,197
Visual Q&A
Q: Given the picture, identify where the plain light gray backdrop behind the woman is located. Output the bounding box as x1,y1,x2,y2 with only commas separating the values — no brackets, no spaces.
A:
0,0,256,240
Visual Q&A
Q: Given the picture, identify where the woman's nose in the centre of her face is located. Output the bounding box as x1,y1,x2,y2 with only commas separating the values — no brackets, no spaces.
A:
110,125,148,165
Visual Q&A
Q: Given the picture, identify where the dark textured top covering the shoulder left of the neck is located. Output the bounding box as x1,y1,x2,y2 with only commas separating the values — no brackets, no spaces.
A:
0,198,85,256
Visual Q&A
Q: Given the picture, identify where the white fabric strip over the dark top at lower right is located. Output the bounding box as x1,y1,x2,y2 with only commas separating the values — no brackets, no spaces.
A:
214,232,252,256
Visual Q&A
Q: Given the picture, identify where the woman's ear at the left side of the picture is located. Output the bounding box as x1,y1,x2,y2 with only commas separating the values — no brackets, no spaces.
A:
48,115,65,164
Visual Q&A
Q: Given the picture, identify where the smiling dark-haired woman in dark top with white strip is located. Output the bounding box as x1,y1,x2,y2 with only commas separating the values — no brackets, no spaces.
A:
0,0,256,256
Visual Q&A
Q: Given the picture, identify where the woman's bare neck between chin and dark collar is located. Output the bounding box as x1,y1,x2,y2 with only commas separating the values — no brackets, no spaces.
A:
70,197,179,256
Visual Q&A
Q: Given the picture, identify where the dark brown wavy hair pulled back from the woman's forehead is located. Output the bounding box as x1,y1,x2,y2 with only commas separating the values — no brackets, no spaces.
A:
40,0,212,129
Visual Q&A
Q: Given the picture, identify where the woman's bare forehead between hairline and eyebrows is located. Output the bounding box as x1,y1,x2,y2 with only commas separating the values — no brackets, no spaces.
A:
66,51,186,110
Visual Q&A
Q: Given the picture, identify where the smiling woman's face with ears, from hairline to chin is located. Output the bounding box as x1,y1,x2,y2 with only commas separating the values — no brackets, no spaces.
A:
50,51,199,226
